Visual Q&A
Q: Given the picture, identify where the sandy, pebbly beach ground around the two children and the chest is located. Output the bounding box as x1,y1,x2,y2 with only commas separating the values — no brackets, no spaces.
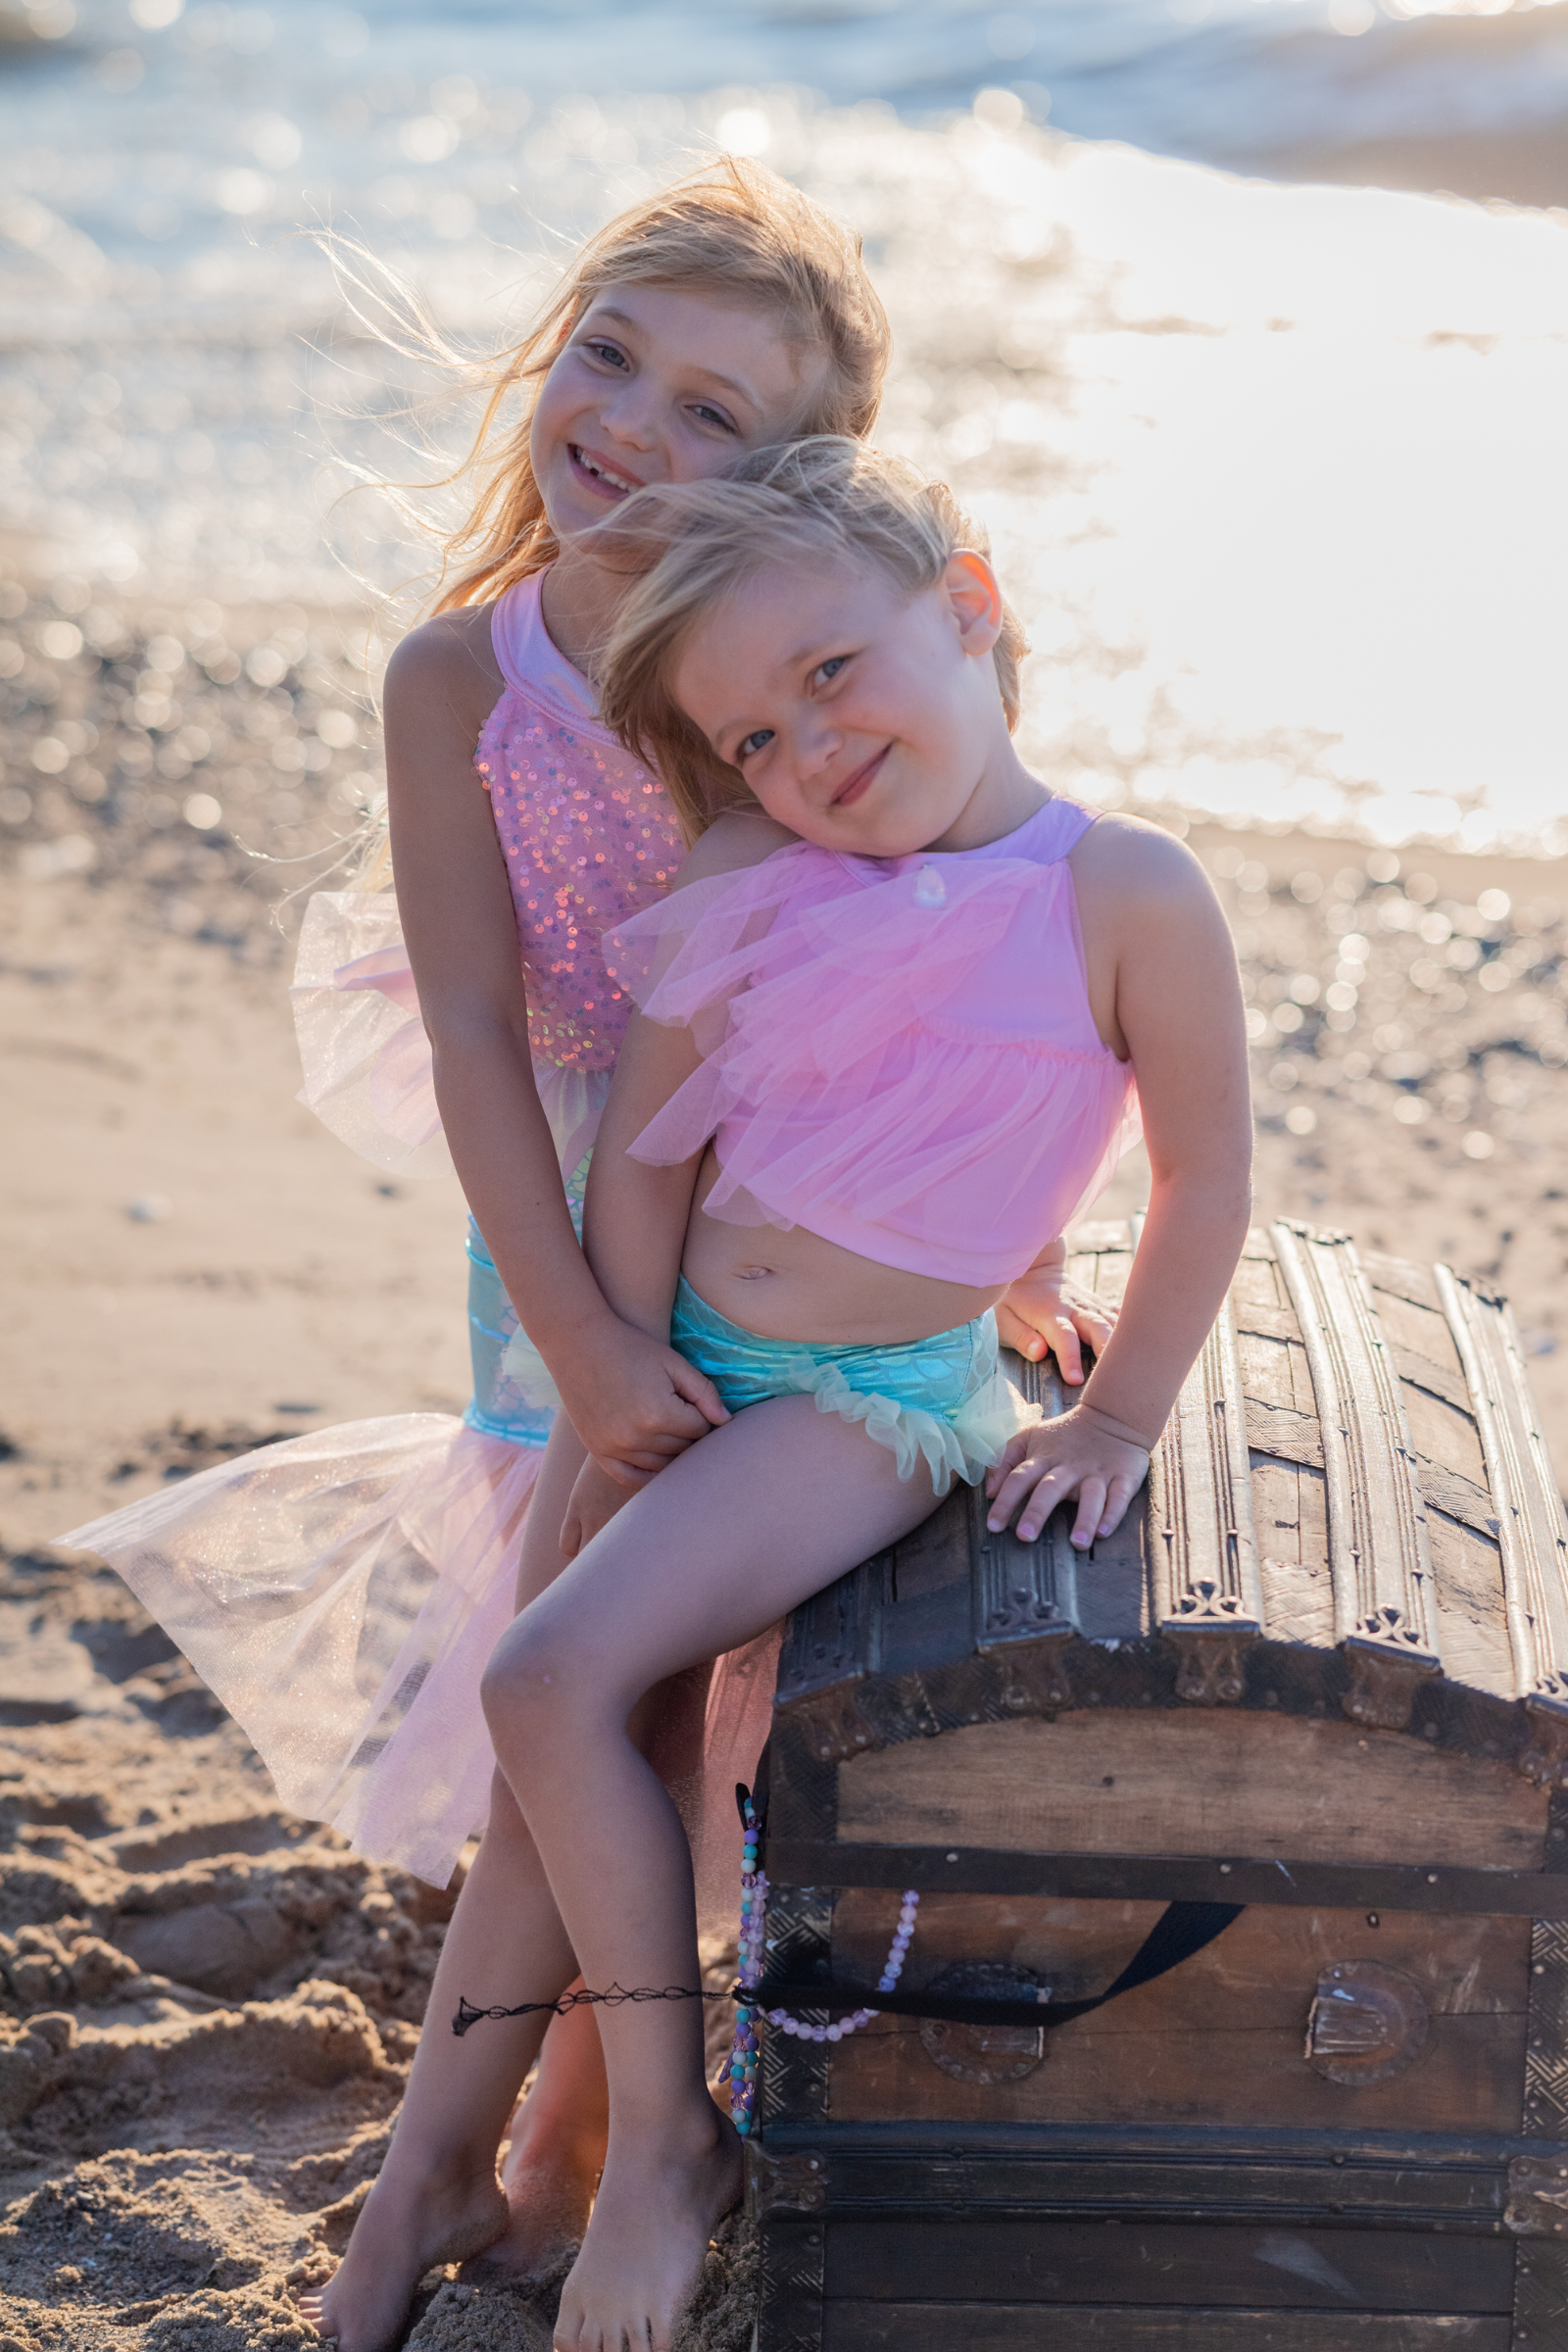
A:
0,588,1568,2352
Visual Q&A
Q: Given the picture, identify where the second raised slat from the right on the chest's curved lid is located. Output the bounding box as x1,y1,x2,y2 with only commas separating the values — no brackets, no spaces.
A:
1274,1221,1441,1731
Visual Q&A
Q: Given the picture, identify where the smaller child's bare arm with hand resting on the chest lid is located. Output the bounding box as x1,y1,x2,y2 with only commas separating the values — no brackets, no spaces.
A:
987,818,1253,1545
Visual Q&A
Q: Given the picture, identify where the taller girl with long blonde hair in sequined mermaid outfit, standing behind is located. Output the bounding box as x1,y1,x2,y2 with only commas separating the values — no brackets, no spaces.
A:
64,158,1102,2347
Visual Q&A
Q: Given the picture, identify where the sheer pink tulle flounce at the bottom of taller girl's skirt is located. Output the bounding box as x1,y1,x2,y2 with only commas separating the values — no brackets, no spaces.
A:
59,1413,778,1936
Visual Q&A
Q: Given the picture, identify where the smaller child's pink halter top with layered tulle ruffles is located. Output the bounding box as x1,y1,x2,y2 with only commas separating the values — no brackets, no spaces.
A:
604,800,1138,1289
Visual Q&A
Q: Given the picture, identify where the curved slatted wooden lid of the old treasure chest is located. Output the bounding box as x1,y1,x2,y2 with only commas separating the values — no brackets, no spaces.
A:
778,1223,1568,1786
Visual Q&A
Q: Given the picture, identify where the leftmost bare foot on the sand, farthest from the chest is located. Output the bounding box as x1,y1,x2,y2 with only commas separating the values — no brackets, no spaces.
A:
299,2171,508,2352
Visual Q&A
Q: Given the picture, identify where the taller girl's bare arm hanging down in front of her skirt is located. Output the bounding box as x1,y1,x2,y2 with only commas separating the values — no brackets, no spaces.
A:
385,610,724,1472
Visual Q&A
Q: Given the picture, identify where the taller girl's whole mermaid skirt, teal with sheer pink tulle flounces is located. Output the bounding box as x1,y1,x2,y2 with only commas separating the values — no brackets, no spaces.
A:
61,892,778,1936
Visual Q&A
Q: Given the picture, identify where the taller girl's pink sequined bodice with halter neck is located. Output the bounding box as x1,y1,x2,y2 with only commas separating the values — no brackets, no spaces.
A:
475,574,684,1070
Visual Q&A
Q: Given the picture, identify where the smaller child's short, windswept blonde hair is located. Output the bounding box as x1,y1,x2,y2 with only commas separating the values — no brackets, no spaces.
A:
592,435,1030,842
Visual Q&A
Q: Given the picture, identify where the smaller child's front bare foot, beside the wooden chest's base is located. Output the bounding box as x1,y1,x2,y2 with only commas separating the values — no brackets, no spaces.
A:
555,2115,741,2352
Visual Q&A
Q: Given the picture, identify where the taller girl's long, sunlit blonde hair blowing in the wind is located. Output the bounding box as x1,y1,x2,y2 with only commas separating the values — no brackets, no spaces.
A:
430,155,891,612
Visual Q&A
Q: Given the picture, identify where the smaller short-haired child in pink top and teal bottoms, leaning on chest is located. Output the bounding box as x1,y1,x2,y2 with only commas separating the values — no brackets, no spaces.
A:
451,440,1250,2352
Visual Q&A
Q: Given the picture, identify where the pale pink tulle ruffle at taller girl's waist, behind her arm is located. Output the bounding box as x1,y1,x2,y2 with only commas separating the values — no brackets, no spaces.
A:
289,889,609,1176
